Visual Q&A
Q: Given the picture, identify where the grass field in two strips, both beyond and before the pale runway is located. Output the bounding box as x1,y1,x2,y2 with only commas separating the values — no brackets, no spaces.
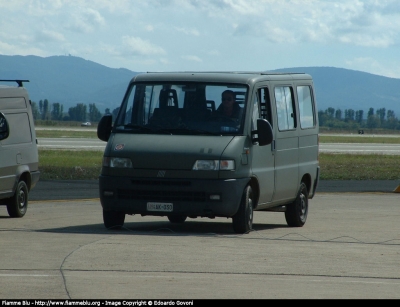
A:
36,129,400,180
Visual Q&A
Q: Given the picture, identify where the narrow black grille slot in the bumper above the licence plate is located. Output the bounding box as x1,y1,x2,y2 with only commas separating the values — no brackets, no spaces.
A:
118,189,206,202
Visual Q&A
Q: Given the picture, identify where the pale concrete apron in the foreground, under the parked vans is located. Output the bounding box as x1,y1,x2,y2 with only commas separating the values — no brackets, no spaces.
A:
0,194,400,300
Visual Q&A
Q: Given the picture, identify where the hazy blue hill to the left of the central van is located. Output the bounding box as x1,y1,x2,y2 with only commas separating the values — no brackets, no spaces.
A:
0,55,138,113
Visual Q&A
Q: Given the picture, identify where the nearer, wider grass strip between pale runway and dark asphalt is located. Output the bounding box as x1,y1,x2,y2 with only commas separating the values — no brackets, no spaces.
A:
39,150,400,180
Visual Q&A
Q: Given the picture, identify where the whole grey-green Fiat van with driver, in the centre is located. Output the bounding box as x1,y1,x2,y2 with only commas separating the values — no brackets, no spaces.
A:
97,72,319,233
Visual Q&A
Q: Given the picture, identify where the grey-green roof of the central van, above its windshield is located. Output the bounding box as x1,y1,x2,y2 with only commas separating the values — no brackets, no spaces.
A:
132,71,312,84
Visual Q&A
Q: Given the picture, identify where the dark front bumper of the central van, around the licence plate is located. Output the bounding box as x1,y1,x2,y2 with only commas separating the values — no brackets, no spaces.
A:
99,175,249,217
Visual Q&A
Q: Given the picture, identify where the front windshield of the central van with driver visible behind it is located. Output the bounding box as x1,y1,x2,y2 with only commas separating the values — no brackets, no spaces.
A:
114,82,247,135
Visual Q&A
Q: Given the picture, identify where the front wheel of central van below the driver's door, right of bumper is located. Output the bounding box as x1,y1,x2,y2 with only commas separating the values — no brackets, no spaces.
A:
232,186,253,234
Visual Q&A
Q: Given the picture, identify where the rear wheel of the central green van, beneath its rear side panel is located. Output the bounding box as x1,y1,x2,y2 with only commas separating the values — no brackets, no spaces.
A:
285,182,308,227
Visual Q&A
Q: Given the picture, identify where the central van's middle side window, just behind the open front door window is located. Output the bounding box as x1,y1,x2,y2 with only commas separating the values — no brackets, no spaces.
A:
275,86,296,131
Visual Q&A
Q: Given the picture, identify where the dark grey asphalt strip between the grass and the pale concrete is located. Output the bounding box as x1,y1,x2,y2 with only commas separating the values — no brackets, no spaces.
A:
29,180,400,200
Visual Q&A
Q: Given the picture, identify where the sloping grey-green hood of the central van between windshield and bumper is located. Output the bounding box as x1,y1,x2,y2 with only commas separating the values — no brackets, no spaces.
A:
105,133,235,170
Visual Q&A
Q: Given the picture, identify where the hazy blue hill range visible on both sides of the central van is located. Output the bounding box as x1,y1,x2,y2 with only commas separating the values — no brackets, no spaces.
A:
0,55,400,118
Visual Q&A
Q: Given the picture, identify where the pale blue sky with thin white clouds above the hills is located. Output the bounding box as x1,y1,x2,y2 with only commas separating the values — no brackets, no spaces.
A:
0,0,400,78
